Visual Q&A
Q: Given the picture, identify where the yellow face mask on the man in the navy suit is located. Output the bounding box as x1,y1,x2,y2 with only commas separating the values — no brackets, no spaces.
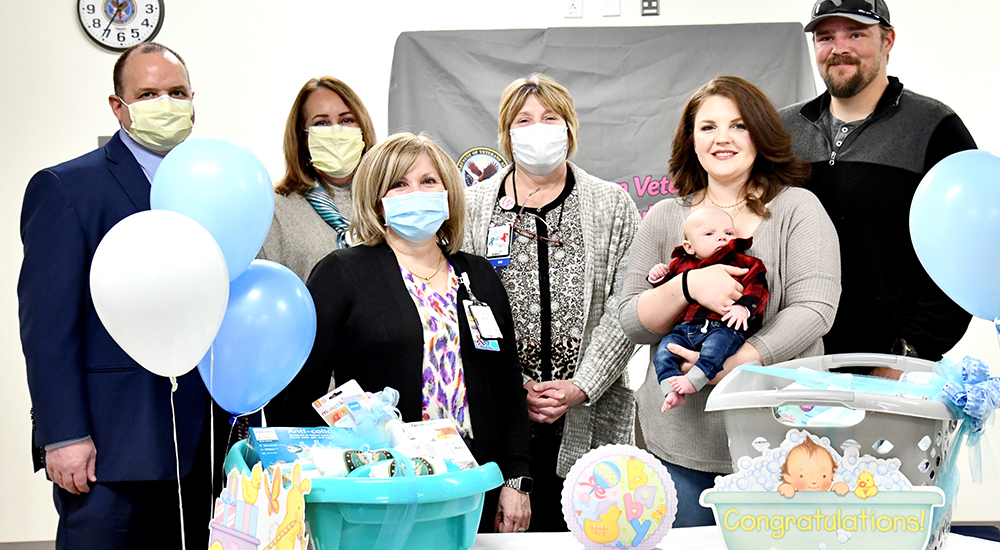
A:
118,95,194,153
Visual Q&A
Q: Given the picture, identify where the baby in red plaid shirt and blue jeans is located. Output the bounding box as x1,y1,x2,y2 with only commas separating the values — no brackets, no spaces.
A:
647,206,768,412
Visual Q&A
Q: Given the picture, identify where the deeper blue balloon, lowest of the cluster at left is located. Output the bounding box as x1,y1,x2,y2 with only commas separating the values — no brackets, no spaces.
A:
198,260,316,415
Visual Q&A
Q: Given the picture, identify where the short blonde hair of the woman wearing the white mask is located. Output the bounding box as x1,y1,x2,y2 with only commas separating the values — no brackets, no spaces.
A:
497,73,580,162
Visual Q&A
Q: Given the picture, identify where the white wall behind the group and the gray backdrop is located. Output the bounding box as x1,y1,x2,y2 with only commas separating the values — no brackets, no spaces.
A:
0,0,1000,542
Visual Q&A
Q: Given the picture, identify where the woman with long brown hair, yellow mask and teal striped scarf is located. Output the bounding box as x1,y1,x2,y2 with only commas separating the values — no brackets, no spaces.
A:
257,76,376,281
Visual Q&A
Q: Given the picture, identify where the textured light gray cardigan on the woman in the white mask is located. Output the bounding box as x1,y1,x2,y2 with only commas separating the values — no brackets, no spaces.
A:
464,163,639,476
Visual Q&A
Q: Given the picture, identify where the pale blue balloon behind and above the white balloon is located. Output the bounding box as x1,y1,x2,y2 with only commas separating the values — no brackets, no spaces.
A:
149,138,274,281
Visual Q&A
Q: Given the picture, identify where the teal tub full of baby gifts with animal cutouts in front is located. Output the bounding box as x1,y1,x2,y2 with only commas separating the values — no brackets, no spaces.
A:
210,386,503,550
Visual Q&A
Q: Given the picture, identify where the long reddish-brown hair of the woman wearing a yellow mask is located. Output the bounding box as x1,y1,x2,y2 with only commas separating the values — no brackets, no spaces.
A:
275,76,377,196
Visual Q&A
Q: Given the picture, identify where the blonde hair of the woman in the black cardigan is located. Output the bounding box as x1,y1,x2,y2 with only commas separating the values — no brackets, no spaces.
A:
351,133,465,254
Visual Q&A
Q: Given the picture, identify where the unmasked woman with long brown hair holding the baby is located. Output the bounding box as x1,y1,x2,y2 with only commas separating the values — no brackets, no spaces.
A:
619,77,840,527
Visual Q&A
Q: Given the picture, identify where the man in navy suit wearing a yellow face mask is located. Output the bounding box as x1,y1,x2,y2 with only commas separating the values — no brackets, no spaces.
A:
17,43,212,549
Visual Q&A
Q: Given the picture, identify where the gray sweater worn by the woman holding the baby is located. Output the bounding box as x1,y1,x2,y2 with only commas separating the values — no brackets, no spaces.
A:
619,188,840,473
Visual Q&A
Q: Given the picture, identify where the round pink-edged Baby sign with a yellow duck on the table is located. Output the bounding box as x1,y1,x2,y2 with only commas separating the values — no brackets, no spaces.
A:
562,445,677,550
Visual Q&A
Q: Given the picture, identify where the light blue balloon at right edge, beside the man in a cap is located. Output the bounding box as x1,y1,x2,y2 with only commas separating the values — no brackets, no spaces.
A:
912,151,1000,320
